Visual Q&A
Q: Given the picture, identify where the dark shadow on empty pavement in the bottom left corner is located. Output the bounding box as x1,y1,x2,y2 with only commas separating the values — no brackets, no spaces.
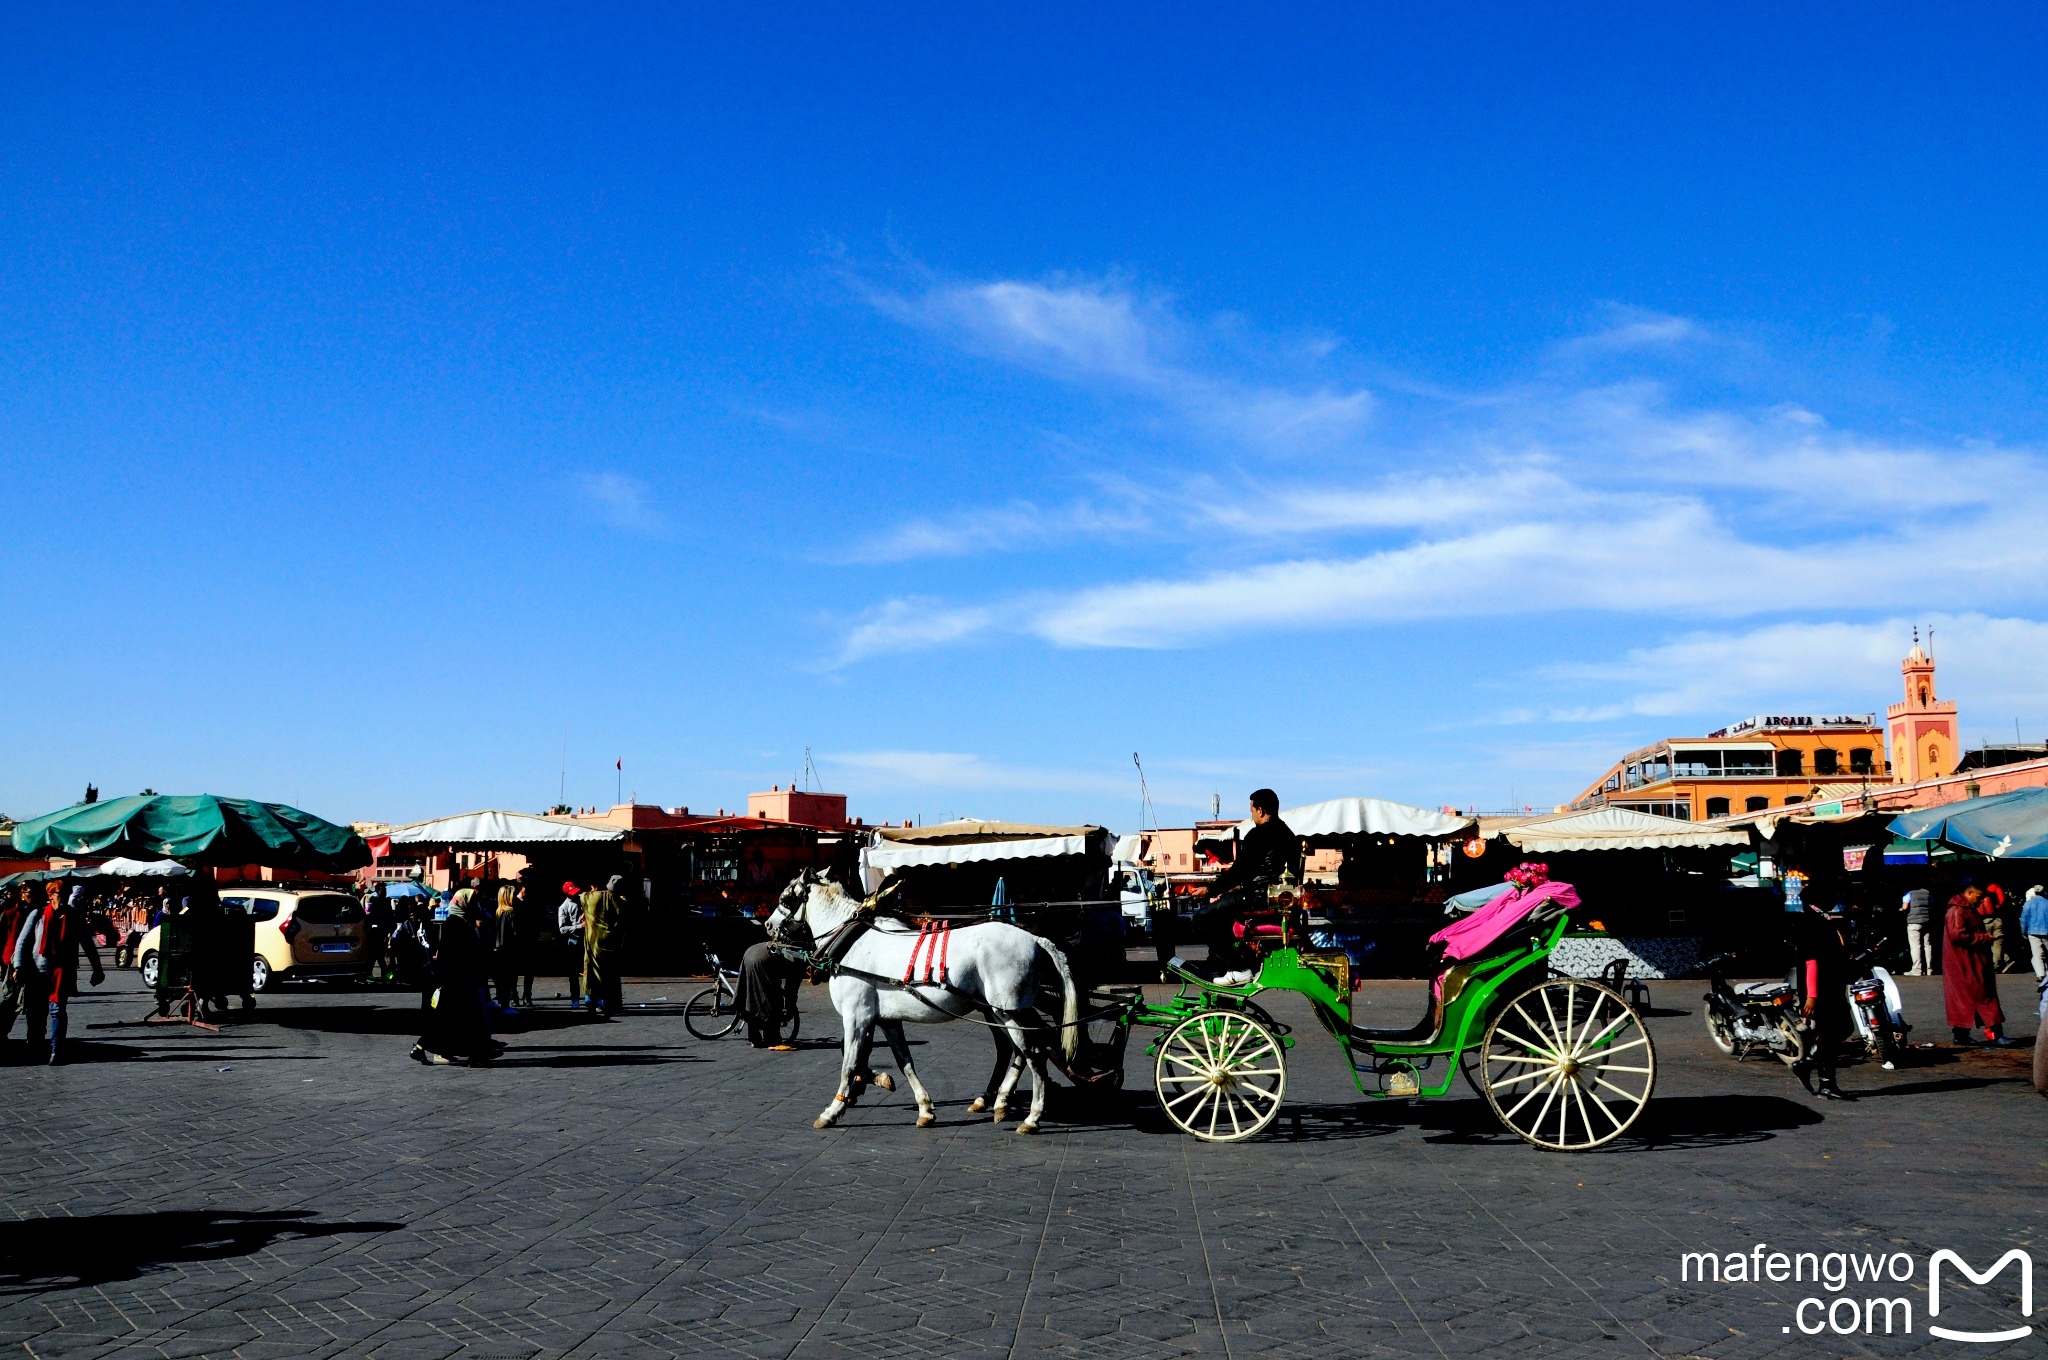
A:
0,1208,406,1294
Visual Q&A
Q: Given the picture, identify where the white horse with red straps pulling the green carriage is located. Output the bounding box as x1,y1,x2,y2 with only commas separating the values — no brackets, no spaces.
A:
776,873,1081,1133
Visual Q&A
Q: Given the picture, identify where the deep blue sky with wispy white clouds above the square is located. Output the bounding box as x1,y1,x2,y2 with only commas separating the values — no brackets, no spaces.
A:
0,6,2048,827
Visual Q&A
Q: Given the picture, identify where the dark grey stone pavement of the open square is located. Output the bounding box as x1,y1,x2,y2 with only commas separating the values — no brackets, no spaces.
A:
0,975,2048,1360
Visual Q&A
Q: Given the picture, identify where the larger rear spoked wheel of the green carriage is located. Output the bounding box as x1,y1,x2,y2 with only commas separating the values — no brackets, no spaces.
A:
1481,977,1657,1153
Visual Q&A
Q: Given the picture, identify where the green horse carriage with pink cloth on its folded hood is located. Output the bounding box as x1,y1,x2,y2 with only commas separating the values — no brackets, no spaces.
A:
1083,883,1657,1153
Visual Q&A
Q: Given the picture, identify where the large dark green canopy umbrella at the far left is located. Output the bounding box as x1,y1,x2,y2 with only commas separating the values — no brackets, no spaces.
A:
14,793,371,873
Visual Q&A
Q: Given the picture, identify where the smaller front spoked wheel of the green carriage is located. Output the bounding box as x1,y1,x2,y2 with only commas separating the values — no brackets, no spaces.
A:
1153,1010,1286,1143
